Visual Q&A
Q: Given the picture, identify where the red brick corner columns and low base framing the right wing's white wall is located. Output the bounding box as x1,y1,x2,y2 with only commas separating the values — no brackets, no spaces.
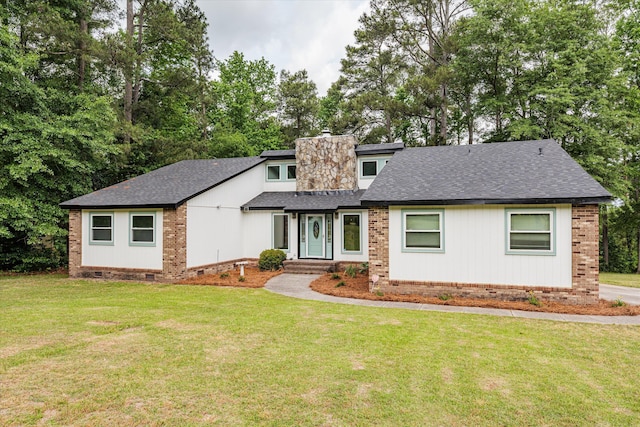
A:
369,205,599,304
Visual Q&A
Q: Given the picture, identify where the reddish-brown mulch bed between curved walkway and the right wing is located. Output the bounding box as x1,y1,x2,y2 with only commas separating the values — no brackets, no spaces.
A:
311,273,640,316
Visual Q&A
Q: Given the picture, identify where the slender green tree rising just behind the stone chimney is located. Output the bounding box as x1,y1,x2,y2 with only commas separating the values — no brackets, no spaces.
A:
278,70,320,145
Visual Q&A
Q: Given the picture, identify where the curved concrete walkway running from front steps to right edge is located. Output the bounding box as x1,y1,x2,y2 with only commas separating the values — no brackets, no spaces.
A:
265,273,640,325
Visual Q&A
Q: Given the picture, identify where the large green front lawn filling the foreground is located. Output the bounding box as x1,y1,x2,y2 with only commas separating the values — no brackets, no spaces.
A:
0,276,640,426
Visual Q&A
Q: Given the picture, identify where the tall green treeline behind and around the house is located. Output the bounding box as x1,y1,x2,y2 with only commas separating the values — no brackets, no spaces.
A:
0,0,640,271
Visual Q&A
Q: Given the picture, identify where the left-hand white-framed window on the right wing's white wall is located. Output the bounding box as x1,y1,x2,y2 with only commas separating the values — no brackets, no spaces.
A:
402,209,444,252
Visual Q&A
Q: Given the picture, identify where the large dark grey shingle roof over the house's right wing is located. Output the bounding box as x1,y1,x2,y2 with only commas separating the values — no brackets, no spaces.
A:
362,140,611,205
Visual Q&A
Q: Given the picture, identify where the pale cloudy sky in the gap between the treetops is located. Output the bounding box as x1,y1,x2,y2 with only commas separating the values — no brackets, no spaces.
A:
196,0,369,96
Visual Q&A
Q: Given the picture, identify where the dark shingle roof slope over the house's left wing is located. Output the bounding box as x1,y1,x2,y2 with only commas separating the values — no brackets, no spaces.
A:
60,157,265,209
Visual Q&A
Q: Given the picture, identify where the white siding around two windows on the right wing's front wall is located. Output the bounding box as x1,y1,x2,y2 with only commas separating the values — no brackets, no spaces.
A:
389,205,572,288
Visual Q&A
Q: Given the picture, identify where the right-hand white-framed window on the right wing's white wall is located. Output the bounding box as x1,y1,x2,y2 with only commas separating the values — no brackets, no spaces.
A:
505,208,555,255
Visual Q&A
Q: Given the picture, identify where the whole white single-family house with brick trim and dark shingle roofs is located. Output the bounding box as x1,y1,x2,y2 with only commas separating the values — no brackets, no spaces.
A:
61,134,611,304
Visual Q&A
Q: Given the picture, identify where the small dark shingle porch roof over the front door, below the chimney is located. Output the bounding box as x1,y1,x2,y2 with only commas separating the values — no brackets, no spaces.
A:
242,190,364,212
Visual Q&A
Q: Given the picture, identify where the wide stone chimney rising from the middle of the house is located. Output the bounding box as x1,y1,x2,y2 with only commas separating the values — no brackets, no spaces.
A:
296,131,358,191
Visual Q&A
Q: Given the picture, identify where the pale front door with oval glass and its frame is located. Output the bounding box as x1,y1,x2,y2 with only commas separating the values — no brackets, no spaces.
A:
298,213,333,259
